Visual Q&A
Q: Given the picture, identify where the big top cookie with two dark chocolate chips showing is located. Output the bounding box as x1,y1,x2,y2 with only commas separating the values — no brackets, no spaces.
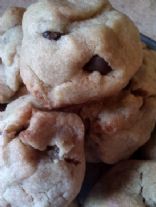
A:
21,0,142,108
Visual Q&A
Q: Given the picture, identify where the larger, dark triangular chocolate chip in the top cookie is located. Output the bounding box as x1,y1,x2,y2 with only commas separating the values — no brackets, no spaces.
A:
83,55,112,75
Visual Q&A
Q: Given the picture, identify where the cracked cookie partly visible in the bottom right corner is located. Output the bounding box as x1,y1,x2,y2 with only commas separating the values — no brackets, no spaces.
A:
84,160,156,207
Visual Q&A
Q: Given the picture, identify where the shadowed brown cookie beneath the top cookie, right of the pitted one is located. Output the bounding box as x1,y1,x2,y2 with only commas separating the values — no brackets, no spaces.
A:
80,91,156,164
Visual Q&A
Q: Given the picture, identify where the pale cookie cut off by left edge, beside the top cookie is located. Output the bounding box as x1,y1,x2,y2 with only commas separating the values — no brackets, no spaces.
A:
0,7,24,103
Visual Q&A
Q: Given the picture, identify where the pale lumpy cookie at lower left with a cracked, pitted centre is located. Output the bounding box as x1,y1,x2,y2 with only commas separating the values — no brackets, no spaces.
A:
0,96,85,207
